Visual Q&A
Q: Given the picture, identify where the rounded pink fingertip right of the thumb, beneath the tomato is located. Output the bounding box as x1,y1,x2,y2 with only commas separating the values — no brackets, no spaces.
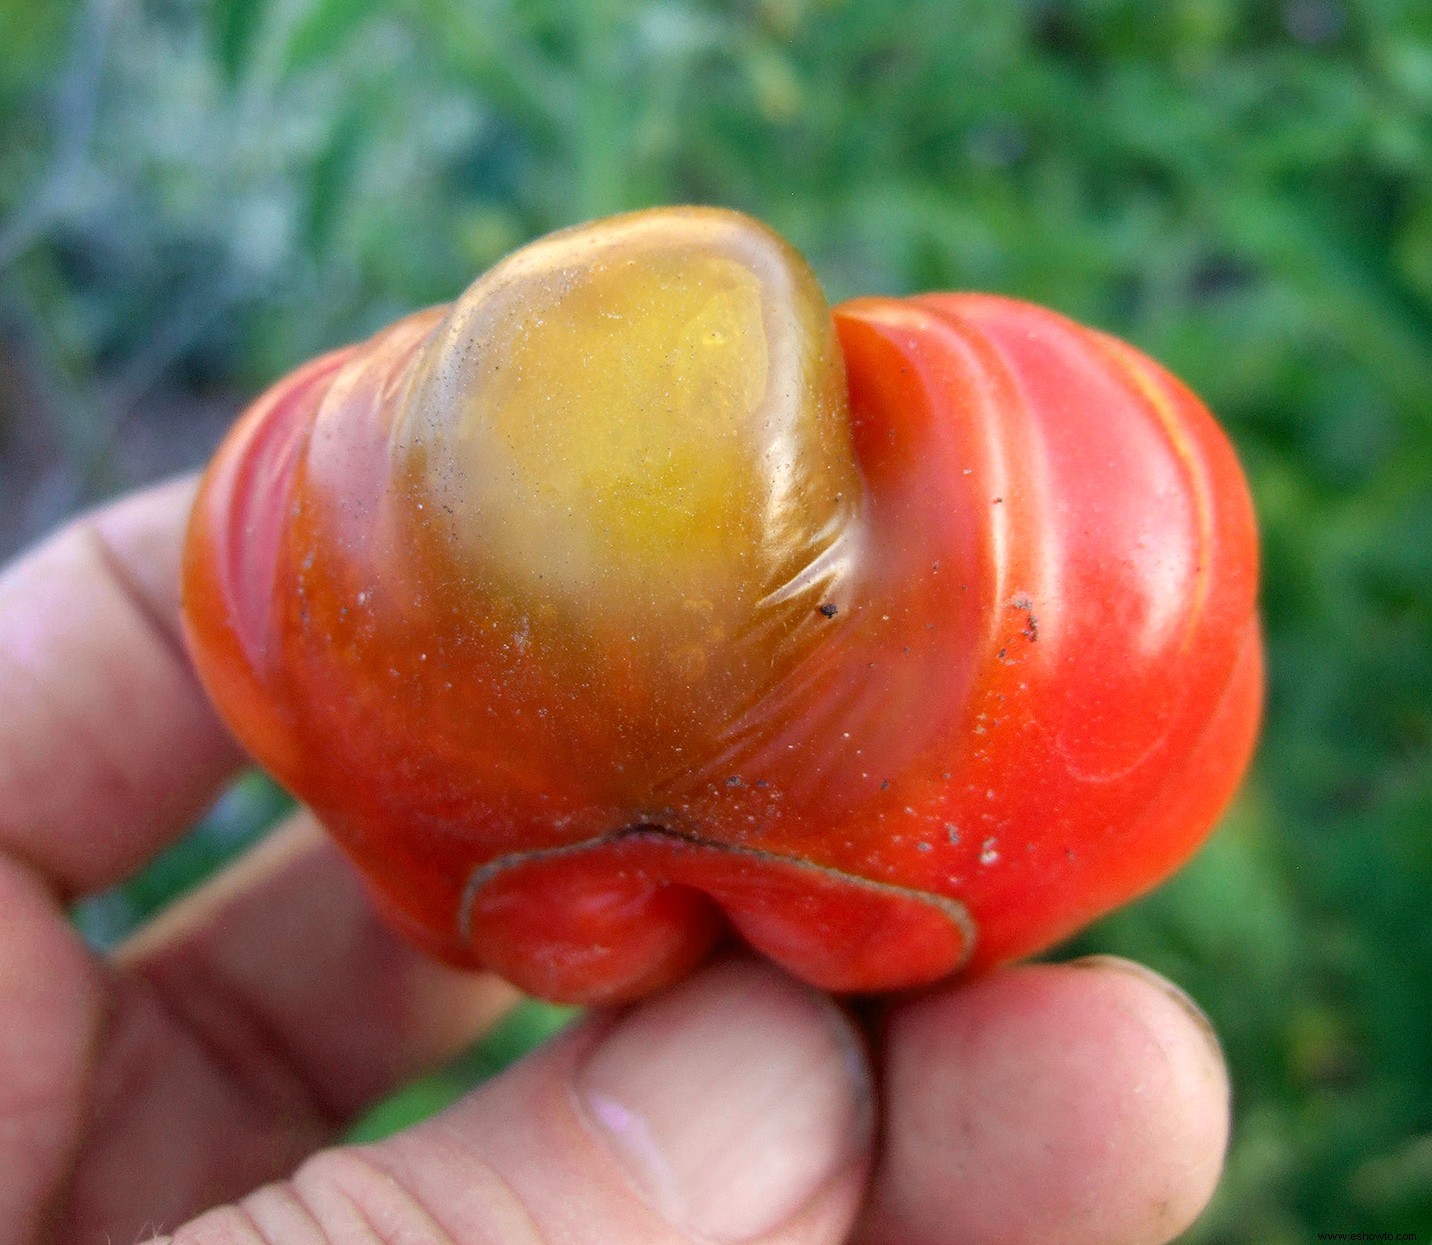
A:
858,957,1229,1245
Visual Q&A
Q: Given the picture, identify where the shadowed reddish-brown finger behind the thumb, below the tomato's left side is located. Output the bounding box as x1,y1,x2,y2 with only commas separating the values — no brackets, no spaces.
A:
60,814,517,1241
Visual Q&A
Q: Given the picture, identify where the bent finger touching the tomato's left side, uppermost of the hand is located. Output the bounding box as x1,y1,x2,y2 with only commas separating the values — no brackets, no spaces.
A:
0,480,241,895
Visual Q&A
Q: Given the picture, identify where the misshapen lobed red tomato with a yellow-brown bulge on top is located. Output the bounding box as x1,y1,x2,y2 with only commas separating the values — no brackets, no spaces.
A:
183,208,1262,1001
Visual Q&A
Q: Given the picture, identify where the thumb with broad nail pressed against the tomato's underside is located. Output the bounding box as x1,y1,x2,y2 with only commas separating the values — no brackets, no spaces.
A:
156,960,872,1245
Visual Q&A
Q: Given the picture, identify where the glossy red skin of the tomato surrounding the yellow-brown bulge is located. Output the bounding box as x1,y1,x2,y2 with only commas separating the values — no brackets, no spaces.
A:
185,223,1262,1003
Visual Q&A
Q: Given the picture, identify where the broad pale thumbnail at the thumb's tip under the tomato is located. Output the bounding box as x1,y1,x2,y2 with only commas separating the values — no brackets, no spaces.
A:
576,961,872,1242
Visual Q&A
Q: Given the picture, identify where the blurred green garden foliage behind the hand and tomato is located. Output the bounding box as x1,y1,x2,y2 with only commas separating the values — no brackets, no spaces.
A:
0,0,1432,1245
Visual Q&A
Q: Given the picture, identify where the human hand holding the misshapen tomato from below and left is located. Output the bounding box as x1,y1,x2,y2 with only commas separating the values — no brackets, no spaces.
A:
0,481,1227,1245
